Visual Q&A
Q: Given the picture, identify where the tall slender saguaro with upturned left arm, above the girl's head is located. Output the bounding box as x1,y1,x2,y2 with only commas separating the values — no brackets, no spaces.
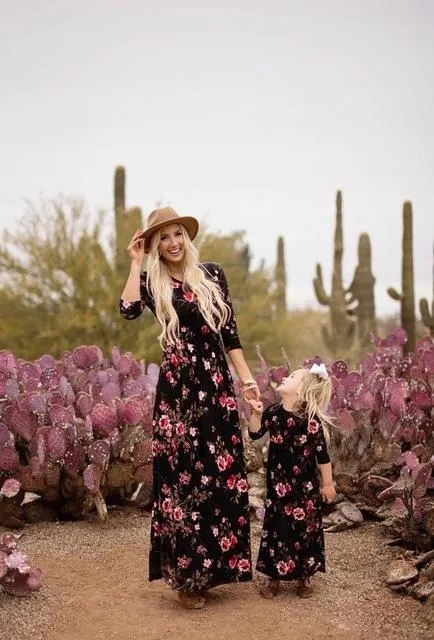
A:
313,191,356,356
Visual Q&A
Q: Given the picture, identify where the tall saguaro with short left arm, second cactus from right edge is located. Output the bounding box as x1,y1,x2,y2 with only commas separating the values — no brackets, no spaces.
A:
387,202,416,352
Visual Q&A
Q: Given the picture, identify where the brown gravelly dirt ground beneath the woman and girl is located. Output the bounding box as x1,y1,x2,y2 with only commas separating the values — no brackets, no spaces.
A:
0,511,433,640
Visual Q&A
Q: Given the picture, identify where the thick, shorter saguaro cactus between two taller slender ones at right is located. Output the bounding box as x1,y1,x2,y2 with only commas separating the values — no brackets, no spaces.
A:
347,233,377,348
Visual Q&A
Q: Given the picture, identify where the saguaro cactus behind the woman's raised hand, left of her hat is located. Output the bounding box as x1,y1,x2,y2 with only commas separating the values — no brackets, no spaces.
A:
114,167,142,279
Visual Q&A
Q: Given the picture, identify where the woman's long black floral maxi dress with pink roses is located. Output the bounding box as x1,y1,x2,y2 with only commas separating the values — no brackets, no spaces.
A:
120,263,252,591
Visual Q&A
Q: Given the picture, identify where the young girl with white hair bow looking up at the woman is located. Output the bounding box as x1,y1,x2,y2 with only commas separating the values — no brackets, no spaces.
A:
249,364,336,598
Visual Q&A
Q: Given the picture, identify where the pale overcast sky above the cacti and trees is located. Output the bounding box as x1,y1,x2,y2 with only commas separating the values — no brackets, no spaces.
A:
0,0,434,313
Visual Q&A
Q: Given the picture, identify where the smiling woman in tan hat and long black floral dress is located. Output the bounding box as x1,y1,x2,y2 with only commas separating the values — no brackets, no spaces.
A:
120,207,259,609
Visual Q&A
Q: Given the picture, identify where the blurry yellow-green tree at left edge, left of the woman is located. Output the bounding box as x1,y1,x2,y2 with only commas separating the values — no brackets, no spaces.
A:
0,199,156,359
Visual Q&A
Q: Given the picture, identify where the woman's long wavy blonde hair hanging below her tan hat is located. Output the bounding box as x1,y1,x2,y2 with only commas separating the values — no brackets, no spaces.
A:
146,225,230,348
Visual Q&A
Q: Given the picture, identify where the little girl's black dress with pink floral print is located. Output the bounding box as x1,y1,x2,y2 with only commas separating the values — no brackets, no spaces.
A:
249,404,330,580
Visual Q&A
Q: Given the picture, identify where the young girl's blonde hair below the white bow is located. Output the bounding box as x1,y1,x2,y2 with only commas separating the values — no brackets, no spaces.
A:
294,369,334,445
